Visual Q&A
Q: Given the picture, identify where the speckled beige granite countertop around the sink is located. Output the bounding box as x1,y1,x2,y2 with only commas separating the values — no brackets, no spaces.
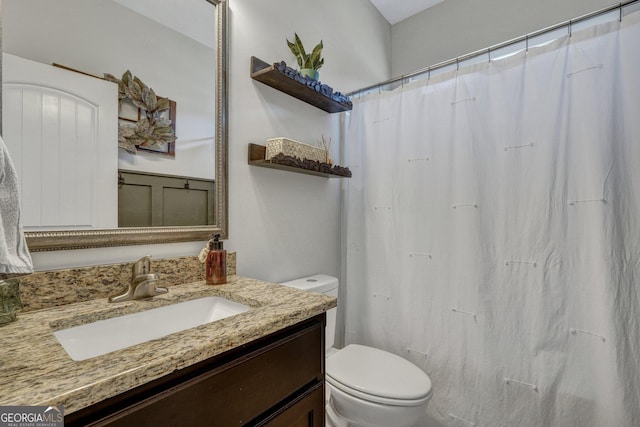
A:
0,276,336,413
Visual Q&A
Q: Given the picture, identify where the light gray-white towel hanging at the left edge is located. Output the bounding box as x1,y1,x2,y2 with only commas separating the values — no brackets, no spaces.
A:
0,137,33,274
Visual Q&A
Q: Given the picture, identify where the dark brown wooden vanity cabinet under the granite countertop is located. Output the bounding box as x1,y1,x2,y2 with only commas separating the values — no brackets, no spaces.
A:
65,313,325,427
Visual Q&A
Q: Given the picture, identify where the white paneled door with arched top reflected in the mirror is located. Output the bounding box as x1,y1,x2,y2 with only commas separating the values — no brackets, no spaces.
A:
2,53,118,231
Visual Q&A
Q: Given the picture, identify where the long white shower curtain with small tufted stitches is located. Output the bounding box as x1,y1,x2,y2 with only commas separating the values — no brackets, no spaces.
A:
344,13,640,427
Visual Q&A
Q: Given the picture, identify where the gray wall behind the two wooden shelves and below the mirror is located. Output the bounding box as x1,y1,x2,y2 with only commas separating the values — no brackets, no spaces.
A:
33,0,391,281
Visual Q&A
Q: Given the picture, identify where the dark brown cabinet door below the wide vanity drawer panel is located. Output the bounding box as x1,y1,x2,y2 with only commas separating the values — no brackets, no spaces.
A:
257,383,325,427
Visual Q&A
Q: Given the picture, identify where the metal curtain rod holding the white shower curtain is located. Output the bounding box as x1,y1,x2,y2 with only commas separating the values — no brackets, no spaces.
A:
347,0,640,96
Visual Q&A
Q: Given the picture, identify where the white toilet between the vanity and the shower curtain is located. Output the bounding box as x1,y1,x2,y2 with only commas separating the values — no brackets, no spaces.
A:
282,274,431,427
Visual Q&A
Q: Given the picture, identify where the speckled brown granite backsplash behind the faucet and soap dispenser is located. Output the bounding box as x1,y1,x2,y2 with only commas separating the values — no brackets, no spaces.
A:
20,252,236,312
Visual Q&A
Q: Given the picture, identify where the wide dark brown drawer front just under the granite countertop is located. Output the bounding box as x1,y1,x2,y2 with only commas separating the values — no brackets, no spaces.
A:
94,323,324,427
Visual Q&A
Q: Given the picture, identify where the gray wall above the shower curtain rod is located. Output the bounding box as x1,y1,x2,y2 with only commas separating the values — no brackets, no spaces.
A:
391,0,618,77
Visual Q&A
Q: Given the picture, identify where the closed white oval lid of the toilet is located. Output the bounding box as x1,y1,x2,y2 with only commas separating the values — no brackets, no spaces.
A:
326,344,431,401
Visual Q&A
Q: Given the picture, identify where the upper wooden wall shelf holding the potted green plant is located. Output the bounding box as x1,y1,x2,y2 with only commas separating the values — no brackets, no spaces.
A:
251,56,351,113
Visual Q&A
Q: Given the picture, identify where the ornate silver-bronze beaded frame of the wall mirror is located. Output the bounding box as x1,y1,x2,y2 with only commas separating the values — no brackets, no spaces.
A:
0,0,229,252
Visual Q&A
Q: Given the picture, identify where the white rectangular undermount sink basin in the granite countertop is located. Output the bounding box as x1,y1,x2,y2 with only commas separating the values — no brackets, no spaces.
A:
53,297,249,361
